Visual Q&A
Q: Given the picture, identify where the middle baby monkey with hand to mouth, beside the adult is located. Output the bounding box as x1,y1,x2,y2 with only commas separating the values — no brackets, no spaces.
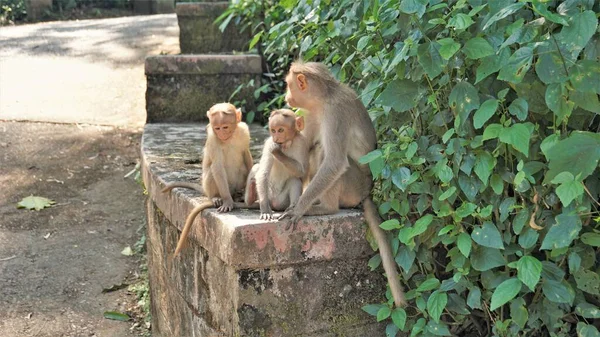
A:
247,109,309,220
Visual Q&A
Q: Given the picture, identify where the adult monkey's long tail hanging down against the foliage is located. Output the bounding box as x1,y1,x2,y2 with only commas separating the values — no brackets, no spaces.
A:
363,197,407,307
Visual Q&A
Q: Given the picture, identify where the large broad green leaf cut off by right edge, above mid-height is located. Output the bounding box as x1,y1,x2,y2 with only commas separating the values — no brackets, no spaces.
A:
542,131,600,183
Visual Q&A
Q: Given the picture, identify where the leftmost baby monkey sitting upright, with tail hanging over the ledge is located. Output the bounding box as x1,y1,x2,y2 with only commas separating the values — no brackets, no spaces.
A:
162,103,252,256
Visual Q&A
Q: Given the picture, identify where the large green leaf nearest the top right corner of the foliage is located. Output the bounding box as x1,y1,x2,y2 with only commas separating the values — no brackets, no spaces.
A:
556,10,598,59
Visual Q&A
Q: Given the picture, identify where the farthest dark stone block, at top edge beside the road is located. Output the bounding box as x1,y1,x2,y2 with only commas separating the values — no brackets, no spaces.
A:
175,1,250,54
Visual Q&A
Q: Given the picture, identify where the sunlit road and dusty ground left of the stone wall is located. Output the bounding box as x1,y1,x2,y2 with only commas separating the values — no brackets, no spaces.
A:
0,15,179,337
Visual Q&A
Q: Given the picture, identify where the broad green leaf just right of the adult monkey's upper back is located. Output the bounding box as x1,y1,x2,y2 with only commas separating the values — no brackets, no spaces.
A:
375,80,419,112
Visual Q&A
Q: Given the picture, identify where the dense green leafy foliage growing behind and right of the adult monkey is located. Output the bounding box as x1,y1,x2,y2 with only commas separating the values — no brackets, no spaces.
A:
220,0,600,336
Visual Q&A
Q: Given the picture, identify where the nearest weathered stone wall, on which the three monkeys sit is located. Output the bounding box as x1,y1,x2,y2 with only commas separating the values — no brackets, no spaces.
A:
142,124,385,337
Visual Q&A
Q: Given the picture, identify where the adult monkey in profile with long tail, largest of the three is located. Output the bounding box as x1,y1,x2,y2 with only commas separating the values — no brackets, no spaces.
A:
279,61,406,306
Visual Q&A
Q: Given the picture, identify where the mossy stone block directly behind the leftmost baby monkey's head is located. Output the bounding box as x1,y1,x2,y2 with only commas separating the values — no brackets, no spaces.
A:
146,55,262,123
